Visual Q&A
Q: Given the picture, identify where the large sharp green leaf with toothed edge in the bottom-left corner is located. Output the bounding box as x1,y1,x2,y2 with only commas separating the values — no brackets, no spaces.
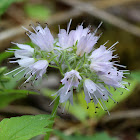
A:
0,115,53,140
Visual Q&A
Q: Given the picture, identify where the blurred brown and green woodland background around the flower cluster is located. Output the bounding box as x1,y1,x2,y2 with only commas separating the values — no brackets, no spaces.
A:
0,0,140,140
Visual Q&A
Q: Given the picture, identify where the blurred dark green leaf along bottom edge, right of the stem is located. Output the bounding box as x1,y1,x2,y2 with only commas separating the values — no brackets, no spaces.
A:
54,130,116,140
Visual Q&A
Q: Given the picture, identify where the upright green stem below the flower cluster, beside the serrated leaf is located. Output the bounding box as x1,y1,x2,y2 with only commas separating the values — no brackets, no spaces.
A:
44,97,59,140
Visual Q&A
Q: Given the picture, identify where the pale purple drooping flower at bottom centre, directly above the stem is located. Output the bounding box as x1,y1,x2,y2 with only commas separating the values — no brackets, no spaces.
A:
50,70,82,105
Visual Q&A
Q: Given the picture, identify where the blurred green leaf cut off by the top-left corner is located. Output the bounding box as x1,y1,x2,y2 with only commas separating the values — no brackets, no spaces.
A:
0,0,21,16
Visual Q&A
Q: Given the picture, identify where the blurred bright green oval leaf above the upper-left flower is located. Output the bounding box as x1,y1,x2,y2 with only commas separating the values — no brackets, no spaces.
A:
24,4,51,20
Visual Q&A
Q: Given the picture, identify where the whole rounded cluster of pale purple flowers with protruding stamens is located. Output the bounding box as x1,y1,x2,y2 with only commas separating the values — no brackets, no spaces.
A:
6,20,128,114
